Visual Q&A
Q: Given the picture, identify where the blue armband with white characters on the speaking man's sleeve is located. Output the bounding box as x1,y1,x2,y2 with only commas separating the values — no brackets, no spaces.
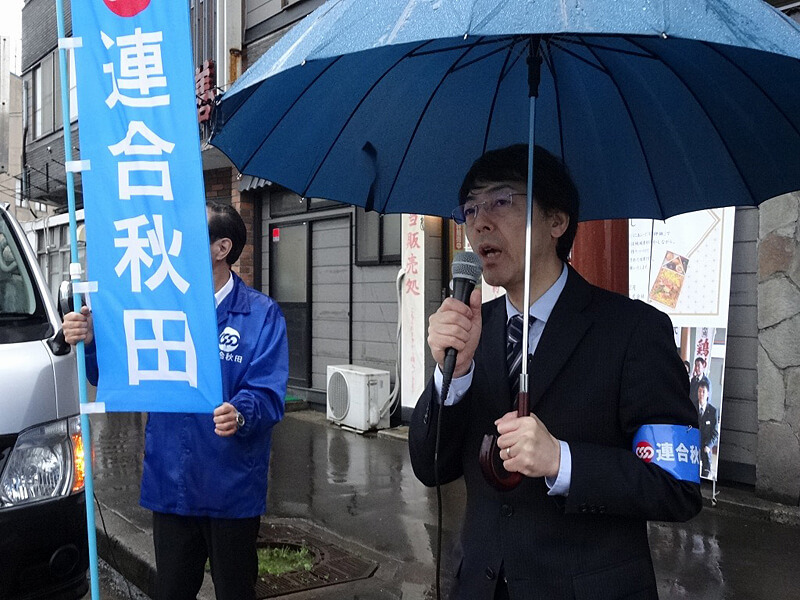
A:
633,425,700,483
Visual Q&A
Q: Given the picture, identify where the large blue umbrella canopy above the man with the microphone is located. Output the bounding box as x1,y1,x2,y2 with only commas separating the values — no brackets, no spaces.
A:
211,0,800,220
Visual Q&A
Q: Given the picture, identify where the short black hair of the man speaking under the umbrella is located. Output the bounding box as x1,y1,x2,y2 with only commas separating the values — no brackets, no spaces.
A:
458,144,580,262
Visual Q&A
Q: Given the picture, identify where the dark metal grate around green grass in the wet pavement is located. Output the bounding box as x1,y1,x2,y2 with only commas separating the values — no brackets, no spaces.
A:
256,523,378,599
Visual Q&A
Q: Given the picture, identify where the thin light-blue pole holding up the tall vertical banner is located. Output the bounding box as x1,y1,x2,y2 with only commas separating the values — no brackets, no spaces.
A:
56,0,100,600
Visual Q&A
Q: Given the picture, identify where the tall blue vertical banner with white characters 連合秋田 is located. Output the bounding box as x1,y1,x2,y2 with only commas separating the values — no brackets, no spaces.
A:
72,0,222,412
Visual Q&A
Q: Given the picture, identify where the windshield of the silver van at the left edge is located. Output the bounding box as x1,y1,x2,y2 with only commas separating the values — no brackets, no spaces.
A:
0,212,52,344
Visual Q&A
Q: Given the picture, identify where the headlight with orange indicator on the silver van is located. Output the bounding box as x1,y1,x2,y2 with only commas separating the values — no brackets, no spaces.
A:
0,416,85,506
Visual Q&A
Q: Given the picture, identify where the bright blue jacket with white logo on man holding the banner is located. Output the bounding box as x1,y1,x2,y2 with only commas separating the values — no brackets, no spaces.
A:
87,273,289,519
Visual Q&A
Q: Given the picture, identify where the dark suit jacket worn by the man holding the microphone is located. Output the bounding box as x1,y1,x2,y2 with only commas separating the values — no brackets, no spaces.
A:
409,268,702,600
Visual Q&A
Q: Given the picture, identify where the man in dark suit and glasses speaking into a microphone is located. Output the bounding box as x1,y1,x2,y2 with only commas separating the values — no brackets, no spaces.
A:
409,145,702,600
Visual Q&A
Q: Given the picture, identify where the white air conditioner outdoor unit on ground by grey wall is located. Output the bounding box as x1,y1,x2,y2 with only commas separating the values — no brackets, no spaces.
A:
327,365,389,431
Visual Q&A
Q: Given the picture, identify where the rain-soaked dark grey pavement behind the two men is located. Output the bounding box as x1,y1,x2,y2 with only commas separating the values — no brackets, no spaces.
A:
87,411,800,600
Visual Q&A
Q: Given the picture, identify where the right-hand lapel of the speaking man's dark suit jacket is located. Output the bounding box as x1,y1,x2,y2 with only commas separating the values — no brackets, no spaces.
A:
528,267,592,410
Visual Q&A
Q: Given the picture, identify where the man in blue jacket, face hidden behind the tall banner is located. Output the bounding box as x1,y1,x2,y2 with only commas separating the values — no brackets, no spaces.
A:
64,203,289,600
